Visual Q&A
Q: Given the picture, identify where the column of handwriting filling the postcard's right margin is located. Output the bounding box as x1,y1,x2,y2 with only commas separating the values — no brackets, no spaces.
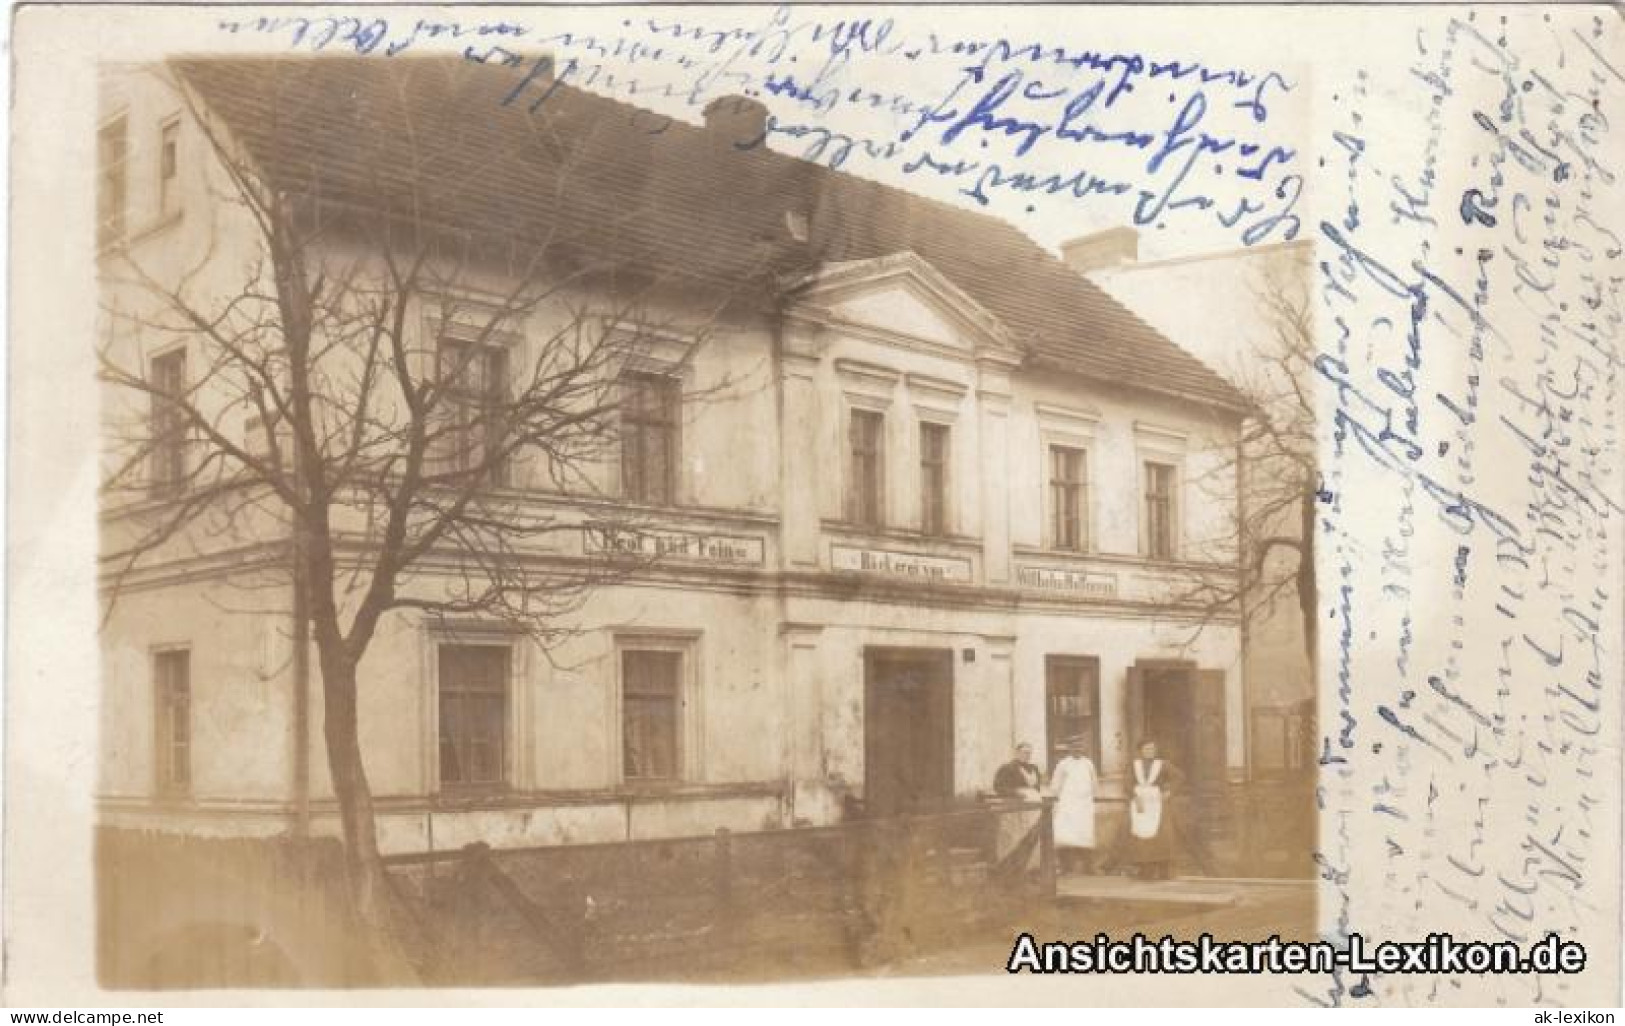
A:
1305,8,1625,1005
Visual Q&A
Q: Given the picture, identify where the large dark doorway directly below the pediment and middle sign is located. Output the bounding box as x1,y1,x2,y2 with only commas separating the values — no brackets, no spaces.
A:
863,647,954,816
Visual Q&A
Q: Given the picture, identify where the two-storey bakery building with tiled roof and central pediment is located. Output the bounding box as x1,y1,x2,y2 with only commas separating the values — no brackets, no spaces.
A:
98,57,1248,852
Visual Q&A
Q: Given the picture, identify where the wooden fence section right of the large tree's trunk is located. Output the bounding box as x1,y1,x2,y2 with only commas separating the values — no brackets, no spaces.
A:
388,802,1055,985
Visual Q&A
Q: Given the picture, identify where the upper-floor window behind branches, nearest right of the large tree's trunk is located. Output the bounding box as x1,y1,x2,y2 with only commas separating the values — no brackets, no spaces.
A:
436,337,507,485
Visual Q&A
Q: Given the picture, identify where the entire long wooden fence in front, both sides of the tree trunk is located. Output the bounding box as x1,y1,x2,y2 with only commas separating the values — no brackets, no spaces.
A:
96,802,1055,989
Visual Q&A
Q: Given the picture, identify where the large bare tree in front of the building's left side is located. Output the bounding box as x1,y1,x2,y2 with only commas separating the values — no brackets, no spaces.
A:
101,60,754,949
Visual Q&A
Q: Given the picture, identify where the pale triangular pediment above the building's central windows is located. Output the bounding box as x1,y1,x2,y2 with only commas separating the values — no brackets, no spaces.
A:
776,250,1009,356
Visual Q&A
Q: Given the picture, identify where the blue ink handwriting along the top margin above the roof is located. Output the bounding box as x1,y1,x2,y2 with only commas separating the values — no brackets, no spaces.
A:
219,7,1305,246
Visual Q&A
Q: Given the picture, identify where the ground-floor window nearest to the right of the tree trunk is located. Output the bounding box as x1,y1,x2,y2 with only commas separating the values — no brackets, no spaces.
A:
439,644,510,787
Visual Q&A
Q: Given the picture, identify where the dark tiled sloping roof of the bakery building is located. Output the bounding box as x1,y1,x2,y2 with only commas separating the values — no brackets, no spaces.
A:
176,57,1240,408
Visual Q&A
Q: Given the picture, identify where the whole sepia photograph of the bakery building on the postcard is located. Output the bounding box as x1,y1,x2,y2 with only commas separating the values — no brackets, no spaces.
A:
96,46,1315,985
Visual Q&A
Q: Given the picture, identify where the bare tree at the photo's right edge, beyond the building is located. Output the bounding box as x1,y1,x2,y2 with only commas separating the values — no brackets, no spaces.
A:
1177,275,1320,673
